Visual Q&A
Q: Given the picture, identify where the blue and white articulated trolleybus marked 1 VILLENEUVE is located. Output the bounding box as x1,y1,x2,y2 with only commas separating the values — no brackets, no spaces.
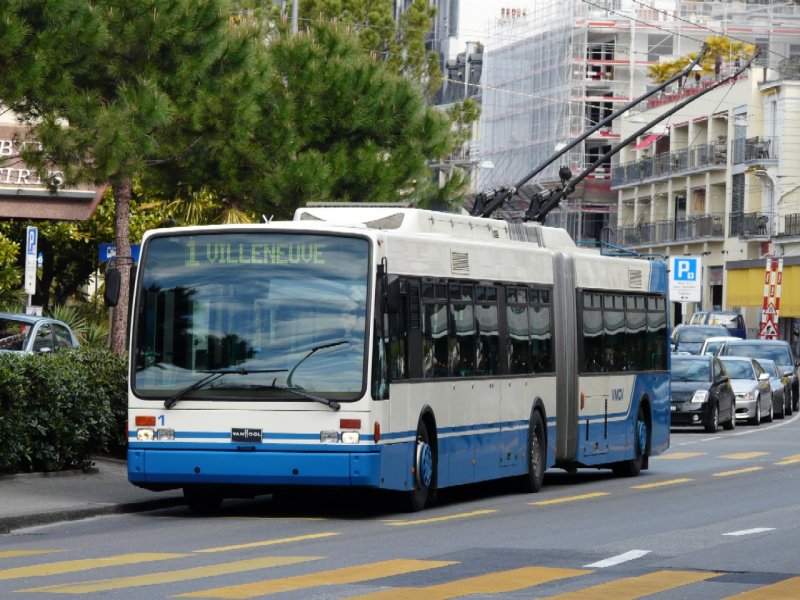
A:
128,206,670,510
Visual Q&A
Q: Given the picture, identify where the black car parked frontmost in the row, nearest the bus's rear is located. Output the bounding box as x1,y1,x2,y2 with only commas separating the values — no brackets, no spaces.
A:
670,354,736,433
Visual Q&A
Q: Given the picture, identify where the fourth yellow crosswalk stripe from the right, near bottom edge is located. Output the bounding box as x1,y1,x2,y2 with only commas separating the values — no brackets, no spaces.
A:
176,559,458,598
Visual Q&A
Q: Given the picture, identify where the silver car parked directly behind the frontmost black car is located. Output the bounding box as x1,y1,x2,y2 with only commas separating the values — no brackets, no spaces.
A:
720,356,773,425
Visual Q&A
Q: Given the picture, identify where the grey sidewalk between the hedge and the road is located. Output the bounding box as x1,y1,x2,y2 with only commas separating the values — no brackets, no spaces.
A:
0,458,183,534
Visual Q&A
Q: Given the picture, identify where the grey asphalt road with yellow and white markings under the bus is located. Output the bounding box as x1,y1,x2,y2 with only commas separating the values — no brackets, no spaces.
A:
0,414,800,600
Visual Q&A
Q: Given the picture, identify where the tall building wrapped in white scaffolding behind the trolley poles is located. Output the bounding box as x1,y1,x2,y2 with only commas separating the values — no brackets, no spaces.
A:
472,0,800,244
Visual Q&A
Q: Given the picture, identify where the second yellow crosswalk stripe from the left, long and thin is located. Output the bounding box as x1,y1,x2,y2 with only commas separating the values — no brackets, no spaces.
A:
18,556,324,594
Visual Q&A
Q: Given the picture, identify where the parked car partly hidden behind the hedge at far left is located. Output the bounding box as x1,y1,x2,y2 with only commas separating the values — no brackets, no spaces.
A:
0,313,79,354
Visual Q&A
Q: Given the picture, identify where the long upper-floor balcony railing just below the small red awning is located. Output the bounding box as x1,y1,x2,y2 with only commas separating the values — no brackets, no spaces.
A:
611,142,728,186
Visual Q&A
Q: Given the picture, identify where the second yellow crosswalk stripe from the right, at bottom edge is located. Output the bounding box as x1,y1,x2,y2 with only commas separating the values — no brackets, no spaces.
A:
549,571,719,600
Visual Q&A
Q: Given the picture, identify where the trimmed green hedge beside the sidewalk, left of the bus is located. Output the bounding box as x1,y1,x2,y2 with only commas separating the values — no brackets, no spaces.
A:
0,348,128,473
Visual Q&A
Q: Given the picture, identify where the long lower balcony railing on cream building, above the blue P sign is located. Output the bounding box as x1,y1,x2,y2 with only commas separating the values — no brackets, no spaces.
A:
612,213,725,247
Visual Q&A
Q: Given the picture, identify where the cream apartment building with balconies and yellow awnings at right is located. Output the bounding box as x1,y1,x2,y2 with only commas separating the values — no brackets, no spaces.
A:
606,67,800,352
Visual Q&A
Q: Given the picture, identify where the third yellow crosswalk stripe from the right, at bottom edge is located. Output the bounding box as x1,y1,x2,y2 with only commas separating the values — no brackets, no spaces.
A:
344,567,592,600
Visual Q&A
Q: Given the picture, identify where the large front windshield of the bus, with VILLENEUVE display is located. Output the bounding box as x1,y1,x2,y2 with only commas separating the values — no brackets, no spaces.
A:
132,231,369,401
